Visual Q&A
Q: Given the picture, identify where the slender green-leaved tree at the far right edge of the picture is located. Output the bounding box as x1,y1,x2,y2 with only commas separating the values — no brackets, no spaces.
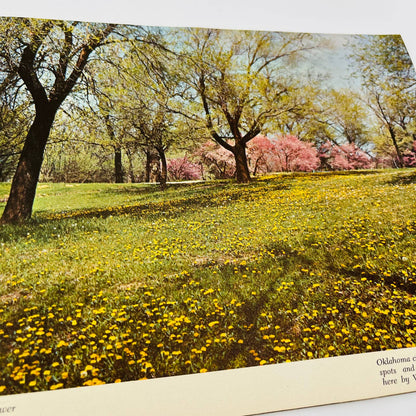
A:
352,35,416,167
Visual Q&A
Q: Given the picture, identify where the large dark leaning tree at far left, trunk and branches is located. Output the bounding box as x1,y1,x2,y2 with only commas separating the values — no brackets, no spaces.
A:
0,18,115,224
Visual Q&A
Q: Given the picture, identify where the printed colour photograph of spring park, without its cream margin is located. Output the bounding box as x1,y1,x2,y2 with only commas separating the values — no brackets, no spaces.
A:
0,17,416,395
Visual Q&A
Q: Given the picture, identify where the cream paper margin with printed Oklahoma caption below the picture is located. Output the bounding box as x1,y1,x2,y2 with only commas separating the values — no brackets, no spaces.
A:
0,348,416,416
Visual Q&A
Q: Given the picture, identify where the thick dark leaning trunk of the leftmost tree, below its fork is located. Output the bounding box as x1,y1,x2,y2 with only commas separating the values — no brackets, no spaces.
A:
0,108,56,224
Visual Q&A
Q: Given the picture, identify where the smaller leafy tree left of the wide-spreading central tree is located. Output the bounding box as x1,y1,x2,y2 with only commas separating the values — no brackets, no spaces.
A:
112,29,198,189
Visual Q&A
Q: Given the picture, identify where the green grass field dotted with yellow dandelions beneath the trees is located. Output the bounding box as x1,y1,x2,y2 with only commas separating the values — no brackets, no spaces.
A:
0,169,416,394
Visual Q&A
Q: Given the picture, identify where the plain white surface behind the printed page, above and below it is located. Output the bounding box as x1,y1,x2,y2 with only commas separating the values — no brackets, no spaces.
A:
0,0,416,416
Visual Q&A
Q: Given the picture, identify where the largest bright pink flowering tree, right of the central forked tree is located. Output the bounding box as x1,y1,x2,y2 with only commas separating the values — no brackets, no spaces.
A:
273,135,320,172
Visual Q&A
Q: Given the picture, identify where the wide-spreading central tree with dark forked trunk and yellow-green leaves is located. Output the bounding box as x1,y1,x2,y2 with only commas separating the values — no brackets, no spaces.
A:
176,29,316,182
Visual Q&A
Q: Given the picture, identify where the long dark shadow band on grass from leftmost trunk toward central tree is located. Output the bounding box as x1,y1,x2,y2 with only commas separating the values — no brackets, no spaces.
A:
0,174,290,242
